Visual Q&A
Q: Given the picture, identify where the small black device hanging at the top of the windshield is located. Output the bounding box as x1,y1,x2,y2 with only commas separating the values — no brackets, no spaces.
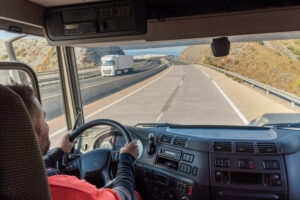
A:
211,37,230,57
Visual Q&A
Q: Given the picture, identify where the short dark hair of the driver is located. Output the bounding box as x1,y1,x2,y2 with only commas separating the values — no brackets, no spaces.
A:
7,84,40,120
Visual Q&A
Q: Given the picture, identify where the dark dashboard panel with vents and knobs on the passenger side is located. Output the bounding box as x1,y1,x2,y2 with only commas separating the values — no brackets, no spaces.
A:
209,141,288,200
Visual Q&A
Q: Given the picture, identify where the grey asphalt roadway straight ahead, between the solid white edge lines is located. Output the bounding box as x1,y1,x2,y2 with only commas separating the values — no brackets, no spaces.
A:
86,65,245,125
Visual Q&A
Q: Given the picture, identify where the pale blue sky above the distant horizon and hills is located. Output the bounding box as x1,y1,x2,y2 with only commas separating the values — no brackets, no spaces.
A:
0,30,186,57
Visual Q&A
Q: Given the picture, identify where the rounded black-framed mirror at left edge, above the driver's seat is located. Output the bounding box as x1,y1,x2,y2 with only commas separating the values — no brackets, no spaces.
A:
0,62,41,102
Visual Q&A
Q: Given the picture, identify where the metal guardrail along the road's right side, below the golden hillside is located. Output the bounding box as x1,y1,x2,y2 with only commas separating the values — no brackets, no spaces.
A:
197,63,300,106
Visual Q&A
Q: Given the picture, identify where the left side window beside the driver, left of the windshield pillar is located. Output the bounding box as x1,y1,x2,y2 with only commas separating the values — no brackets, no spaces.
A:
0,31,67,146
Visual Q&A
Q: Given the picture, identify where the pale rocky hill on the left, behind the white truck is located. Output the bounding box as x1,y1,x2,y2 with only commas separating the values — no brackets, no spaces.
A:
0,37,124,72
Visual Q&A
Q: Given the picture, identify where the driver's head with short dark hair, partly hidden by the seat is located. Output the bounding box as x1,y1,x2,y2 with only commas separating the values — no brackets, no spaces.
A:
8,85,50,155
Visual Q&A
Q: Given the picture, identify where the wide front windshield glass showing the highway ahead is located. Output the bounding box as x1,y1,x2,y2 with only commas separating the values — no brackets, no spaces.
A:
76,39,300,125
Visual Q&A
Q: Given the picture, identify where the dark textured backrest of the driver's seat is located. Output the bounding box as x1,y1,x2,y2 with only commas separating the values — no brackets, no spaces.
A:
0,85,51,200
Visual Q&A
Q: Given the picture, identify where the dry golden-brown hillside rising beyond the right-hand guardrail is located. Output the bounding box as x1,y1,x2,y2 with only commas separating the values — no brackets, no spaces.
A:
178,40,300,96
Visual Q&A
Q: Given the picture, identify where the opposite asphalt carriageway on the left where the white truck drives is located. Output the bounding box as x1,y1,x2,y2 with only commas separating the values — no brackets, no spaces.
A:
40,60,161,120
